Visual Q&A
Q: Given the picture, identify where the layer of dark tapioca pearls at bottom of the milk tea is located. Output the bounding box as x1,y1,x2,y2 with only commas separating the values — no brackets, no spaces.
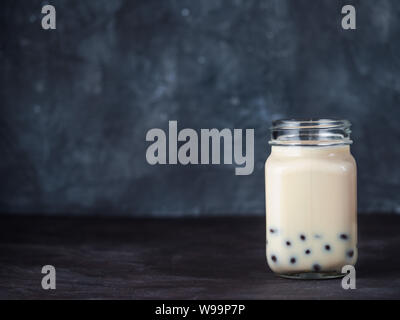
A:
267,228,356,272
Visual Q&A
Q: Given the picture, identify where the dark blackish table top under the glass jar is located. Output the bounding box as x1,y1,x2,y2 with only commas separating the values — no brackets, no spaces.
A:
0,215,400,299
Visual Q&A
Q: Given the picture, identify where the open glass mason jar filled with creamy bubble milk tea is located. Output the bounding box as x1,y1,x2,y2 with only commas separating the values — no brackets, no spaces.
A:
265,119,357,279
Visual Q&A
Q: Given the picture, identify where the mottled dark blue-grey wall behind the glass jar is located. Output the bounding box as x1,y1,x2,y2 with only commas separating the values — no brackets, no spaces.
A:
0,0,400,216
